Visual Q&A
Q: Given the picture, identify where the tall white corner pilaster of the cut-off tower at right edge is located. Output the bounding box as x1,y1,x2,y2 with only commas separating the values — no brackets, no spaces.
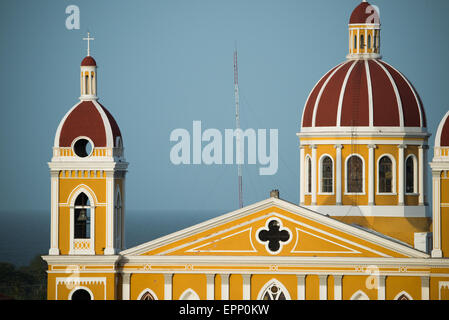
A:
432,171,443,258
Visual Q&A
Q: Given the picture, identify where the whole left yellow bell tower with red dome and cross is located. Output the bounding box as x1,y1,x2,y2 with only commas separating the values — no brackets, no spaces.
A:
49,34,128,256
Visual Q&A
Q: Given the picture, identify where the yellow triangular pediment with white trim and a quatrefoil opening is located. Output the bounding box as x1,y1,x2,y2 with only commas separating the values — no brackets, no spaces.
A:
121,198,427,258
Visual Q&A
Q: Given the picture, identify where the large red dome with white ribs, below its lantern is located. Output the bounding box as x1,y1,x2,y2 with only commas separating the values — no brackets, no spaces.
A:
302,59,426,129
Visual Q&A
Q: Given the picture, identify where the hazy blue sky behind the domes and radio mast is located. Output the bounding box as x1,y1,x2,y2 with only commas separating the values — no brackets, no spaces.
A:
0,0,449,214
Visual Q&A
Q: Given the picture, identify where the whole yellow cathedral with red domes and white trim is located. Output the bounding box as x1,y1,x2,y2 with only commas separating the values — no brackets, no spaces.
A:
43,1,449,300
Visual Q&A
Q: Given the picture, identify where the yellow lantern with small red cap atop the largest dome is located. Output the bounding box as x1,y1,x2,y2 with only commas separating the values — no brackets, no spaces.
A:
347,1,381,59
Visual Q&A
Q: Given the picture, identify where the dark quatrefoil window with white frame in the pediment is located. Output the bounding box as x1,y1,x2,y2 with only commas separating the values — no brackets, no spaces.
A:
257,218,292,254
